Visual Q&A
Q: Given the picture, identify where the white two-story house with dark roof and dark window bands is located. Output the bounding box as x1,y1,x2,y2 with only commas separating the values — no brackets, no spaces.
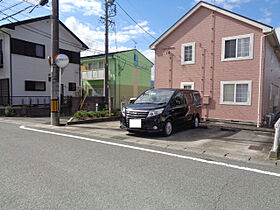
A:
0,16,88,105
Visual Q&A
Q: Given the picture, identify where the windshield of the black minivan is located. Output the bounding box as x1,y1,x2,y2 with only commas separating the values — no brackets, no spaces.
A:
134,89,175,104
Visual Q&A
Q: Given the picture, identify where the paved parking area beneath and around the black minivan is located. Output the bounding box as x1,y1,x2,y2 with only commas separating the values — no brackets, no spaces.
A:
2,118,273,162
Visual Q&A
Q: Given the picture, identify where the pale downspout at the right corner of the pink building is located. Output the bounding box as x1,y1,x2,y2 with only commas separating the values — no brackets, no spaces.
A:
257,31,274,128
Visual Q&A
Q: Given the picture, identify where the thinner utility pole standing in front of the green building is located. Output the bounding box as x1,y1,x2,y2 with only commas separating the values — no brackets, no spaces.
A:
101,0,116,113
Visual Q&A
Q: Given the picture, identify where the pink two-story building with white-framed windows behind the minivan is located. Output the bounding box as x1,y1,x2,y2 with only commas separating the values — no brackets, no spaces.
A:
150,2,280,126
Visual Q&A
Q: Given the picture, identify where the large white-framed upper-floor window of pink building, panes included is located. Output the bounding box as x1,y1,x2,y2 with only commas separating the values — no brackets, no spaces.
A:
222,34,254,61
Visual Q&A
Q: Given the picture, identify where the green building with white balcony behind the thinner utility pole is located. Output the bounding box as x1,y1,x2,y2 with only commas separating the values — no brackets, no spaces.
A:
81,49,153,109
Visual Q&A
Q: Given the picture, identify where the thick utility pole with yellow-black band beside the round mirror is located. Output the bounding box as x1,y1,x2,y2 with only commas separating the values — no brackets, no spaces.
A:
51,0,59,126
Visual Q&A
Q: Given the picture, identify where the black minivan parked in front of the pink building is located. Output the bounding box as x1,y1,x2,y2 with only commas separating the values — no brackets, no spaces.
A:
120,88,201,136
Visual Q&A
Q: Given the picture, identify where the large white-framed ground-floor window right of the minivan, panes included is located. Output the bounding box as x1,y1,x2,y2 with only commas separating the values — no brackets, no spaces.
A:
220,81,252,105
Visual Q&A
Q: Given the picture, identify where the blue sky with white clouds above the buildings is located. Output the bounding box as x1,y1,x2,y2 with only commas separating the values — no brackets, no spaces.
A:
0,0,280,79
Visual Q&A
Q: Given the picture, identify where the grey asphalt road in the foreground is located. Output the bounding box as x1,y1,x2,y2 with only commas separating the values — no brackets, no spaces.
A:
0,123,280,209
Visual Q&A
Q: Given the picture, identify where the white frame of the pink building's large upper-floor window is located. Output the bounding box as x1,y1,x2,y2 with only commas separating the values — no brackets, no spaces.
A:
221,33,254,61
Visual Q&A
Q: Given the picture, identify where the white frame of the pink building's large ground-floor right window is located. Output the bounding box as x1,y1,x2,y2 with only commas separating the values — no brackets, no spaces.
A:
220,80,252,106
